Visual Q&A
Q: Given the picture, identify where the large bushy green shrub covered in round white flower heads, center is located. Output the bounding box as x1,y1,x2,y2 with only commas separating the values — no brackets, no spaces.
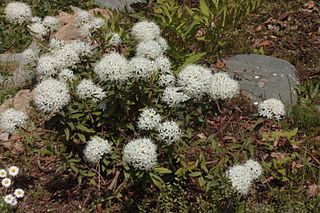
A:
5,10,246,193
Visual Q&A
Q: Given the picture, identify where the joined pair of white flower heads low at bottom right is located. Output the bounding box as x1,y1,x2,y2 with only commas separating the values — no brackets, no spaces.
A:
227,160,263,195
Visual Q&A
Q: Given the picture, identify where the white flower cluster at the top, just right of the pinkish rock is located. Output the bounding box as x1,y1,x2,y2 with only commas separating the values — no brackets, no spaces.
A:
76,10,104,37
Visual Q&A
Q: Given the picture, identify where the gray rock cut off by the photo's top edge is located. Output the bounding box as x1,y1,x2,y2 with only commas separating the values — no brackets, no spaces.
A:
94,0,147,12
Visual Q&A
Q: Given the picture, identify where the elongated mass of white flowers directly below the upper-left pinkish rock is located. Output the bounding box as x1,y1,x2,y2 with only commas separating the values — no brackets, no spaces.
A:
36,39,92,77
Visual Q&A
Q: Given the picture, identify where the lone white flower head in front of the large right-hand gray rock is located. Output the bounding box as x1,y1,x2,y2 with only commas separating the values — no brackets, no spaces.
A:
258,98,286,119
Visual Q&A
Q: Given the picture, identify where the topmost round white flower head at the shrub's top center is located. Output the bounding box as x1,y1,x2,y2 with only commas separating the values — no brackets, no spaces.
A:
132,21,160,41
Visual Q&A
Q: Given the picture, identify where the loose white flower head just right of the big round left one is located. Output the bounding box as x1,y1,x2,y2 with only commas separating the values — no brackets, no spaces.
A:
76,79,106,102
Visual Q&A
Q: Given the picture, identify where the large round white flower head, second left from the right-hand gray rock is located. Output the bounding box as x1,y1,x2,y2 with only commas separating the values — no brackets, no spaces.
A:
178,64,212,98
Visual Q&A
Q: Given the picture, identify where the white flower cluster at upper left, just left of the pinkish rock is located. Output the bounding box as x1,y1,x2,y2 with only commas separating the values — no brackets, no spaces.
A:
28,16,59,39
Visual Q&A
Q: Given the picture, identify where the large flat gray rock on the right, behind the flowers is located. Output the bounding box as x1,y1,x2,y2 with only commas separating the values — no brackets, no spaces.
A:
223,54,300,109
